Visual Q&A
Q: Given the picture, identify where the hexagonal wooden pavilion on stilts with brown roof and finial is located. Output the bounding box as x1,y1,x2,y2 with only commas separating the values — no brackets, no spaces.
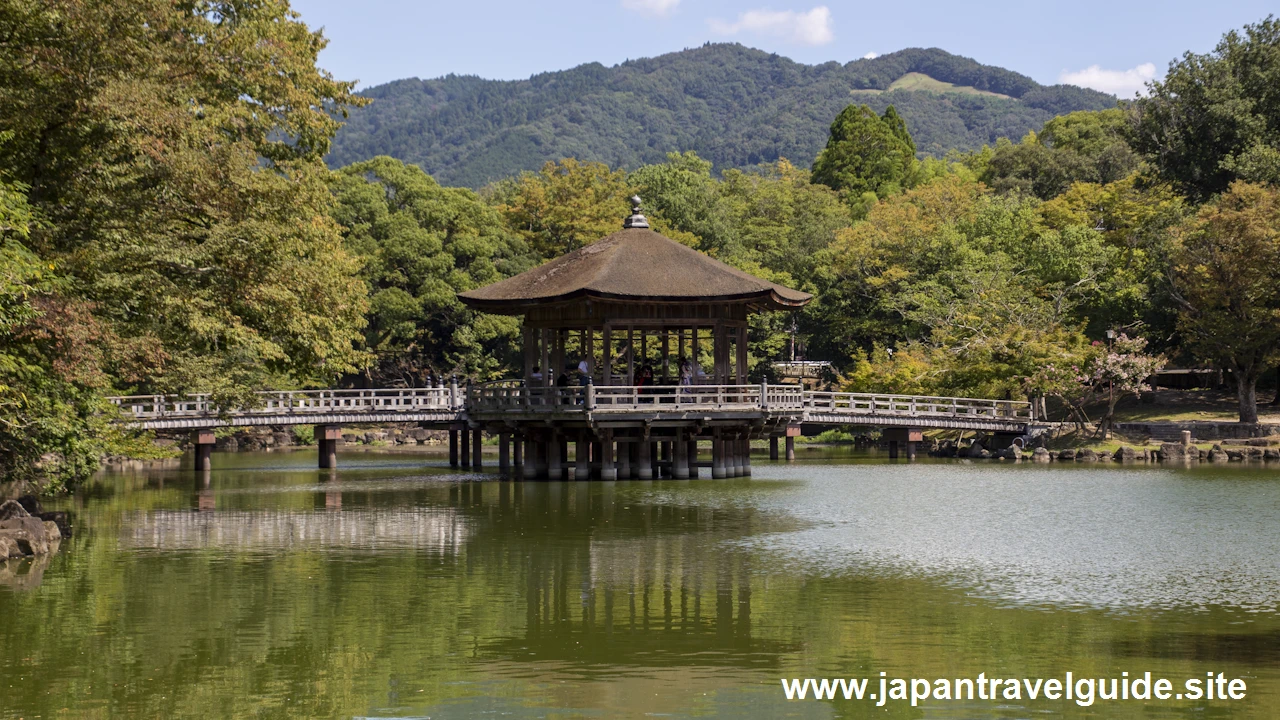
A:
458,197,810,479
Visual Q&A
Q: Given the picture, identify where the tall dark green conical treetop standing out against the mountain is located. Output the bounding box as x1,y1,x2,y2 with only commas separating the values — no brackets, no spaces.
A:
813,105,915,214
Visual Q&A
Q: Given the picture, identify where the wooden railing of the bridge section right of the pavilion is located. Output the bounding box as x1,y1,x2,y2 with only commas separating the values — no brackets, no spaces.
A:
804,391,1036,421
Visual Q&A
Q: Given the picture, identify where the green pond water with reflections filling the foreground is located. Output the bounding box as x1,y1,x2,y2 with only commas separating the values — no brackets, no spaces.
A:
0,452,1280,719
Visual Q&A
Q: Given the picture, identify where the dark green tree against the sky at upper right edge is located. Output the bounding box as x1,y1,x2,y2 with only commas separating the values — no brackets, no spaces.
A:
1133,15,1280,201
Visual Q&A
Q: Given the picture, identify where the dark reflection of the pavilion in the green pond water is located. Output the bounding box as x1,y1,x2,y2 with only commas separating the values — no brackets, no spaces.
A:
451,482,796,667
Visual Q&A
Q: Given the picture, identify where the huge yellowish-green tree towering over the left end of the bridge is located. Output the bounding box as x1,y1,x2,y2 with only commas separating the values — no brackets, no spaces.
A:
0,0,365,404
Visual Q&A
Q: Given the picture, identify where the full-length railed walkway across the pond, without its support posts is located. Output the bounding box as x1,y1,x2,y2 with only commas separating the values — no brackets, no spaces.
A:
110,382,1036,433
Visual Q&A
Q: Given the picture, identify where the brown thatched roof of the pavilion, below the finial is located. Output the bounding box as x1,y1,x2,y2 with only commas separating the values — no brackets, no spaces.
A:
458,227,813,314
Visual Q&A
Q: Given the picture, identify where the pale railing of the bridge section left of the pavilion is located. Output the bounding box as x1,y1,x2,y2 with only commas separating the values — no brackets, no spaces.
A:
108,387,462,420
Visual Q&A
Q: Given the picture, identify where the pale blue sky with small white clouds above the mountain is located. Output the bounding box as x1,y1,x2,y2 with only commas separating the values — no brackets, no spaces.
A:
293,0,1276,96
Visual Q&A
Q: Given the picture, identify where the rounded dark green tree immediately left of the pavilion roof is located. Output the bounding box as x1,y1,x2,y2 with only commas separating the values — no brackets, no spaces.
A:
334,158,536,386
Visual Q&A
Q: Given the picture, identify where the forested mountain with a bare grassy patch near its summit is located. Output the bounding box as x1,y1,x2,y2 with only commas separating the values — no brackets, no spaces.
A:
328,44,1116,187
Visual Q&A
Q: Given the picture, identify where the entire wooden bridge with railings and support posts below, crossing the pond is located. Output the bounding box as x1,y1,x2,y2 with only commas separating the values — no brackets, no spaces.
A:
110,380,1036,477
